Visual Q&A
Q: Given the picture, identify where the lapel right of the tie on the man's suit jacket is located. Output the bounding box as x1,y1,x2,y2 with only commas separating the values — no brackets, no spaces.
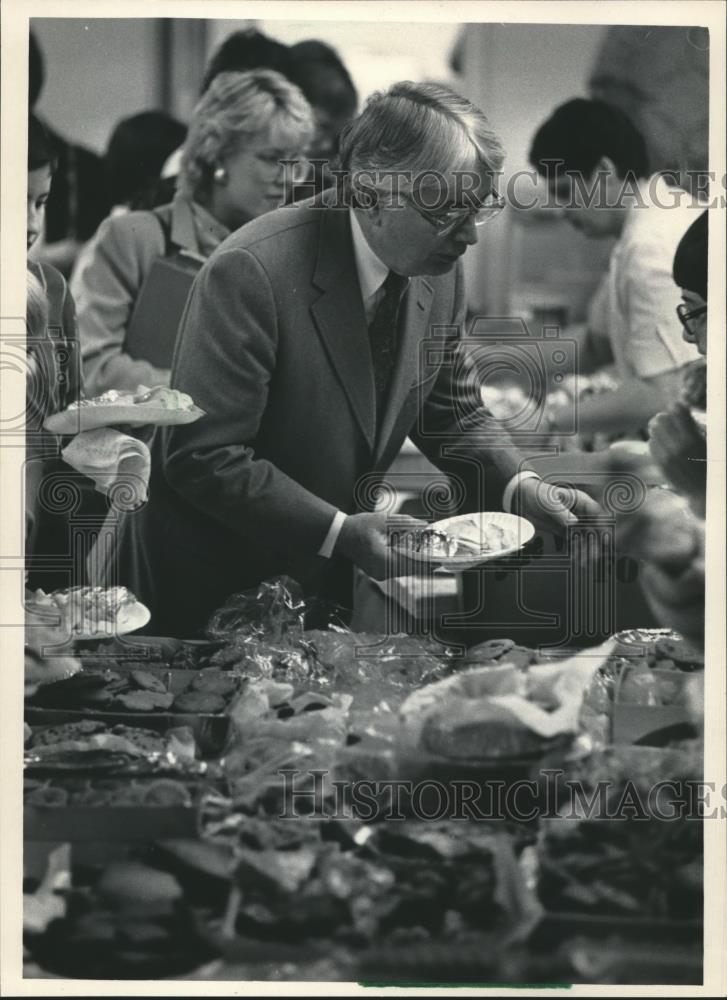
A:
375,278,434,461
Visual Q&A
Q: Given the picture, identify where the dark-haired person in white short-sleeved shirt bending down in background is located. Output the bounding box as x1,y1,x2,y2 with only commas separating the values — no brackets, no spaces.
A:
530,98,699,436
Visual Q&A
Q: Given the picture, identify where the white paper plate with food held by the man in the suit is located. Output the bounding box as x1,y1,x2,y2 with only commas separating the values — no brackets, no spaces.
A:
391,511,535,573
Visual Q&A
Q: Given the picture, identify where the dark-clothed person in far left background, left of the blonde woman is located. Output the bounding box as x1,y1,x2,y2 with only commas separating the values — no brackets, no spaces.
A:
28,31,109,276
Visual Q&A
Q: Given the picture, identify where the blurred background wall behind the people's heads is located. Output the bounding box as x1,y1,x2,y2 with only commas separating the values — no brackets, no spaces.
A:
31,18,709,321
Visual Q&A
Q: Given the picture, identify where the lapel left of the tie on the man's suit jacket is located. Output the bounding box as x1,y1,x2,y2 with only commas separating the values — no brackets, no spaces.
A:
311,208,376,451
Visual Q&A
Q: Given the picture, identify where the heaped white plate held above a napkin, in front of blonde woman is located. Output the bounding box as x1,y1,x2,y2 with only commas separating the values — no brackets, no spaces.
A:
44,385,204,434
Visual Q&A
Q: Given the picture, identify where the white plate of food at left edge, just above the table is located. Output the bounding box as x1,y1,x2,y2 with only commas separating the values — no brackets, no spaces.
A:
26,587,151,642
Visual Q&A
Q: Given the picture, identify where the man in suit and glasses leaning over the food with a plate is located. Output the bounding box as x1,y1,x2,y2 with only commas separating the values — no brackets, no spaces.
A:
108,83,593,636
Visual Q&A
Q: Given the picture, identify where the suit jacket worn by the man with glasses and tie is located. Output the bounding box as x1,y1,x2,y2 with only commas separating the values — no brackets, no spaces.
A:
111,194,520,635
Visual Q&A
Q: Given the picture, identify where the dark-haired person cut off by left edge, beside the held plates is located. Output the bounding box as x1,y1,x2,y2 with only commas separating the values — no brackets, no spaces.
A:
25,114,82,590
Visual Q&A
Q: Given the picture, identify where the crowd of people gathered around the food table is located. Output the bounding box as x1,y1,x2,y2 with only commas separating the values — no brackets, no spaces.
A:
26,31,707,641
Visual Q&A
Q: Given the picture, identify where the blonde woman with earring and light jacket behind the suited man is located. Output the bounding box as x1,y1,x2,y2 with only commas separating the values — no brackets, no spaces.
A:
72,69,314,396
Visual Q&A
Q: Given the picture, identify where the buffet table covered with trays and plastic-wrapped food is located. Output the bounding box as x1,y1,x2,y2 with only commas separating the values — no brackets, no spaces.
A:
24,581,703,985
